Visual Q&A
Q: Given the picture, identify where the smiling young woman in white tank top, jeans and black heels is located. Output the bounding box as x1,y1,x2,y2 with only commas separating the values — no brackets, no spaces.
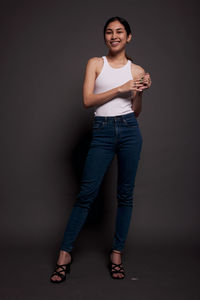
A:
50,17,151,283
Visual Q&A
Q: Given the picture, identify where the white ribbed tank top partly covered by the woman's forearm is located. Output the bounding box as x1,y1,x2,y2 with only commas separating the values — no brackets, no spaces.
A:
94,56,133,116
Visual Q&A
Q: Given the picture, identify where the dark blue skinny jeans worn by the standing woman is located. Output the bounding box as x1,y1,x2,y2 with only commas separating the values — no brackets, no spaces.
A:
60,112,143,252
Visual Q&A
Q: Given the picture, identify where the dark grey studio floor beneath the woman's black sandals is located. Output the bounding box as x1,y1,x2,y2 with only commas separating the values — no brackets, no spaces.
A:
0,245,200,300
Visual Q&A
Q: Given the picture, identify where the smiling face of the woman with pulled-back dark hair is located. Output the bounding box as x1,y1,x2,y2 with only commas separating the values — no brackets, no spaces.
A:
105,21,131,52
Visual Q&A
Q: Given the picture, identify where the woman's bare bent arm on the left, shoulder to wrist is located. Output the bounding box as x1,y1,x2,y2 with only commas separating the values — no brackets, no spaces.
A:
83,57,120,108
